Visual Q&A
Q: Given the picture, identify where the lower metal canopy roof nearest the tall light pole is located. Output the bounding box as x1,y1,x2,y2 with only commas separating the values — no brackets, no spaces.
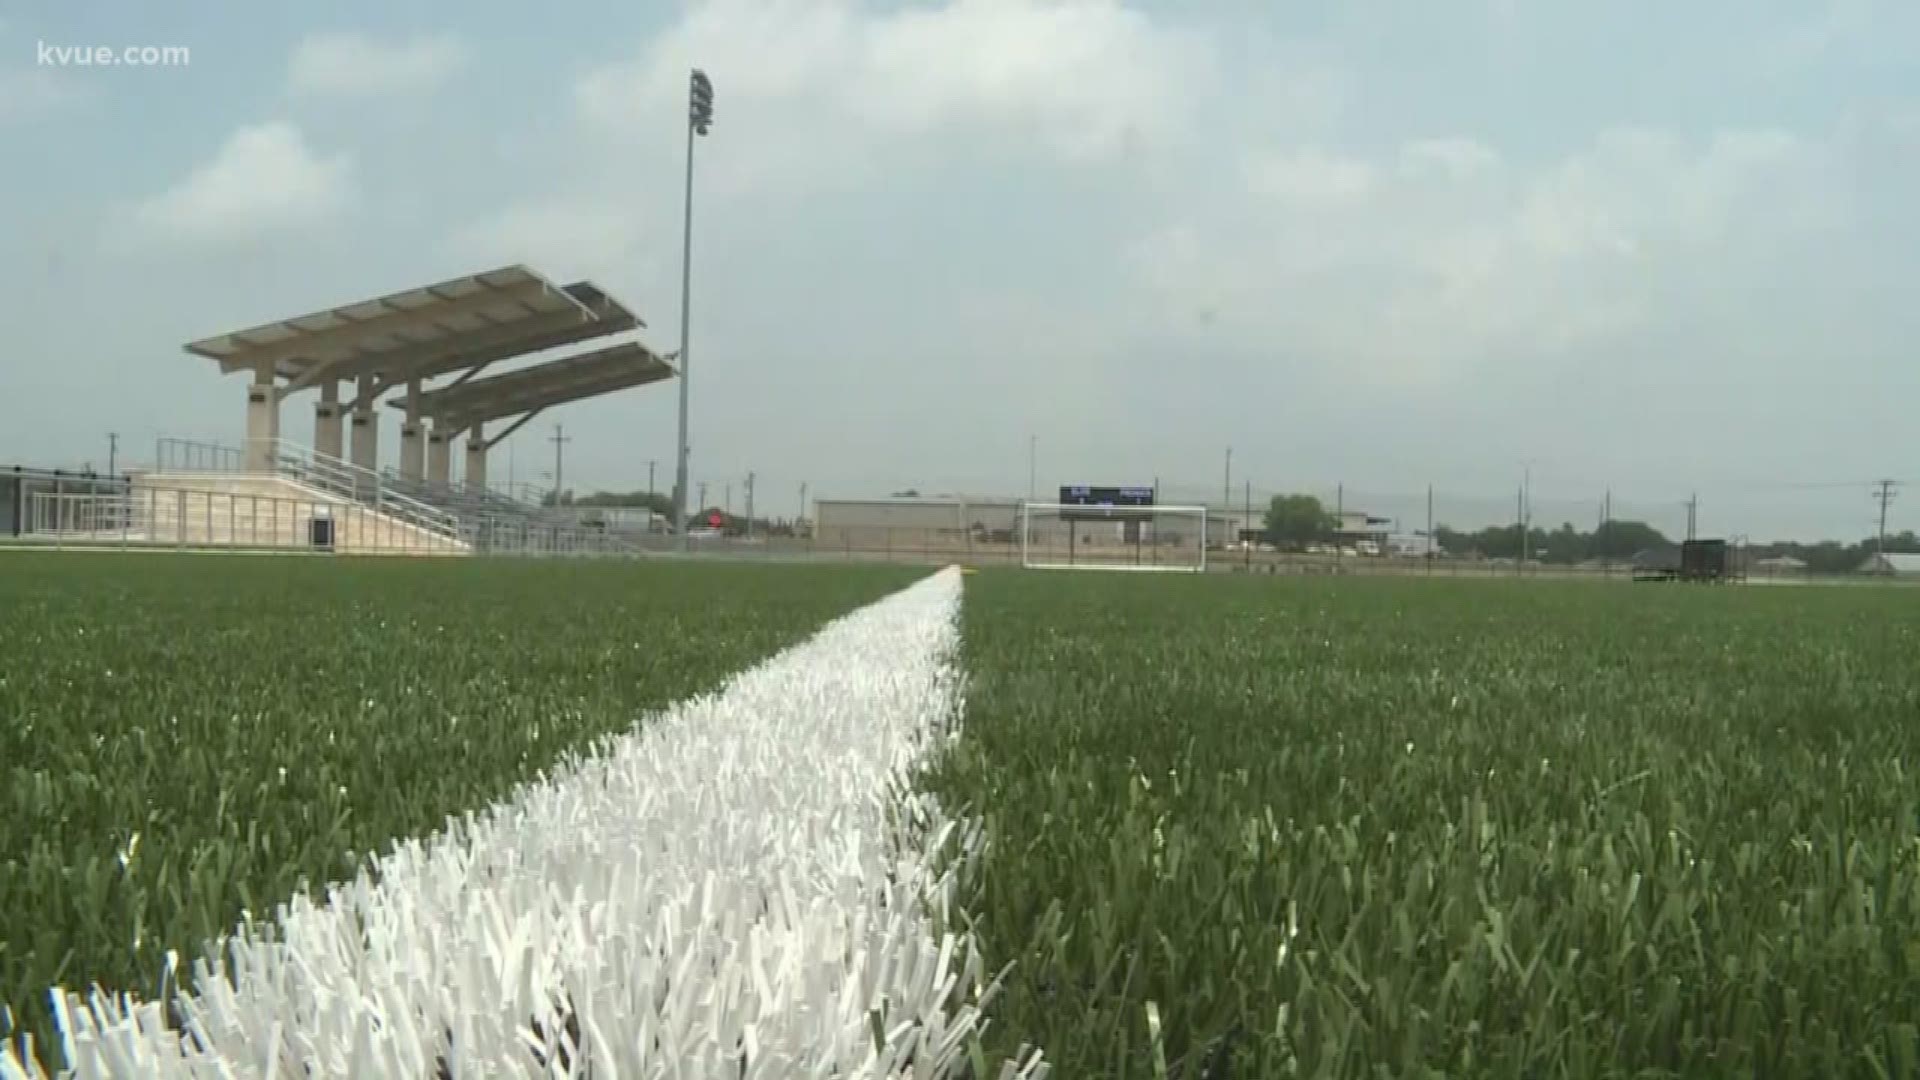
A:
390,342,674,430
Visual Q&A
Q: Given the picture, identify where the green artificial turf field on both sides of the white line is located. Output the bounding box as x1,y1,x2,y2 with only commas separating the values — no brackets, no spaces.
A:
0,553,1920,1078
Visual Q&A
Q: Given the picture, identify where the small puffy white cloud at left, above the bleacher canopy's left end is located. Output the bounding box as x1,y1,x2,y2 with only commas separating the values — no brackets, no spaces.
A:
134,123,353,242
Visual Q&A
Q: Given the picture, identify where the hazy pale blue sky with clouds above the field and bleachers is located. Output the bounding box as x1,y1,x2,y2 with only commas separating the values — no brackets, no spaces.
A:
0,0,1920,538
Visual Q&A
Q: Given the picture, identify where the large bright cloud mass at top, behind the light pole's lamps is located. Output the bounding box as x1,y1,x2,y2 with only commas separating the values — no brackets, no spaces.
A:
449,0,1215,328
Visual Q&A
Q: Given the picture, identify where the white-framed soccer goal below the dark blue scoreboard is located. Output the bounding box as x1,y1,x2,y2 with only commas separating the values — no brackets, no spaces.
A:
1020,502,1206,571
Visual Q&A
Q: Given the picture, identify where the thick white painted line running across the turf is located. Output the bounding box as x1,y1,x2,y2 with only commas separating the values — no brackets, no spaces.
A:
0,569,1044,1080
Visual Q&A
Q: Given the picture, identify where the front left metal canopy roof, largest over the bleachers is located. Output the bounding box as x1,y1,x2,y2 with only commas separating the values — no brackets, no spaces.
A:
186,265,605,384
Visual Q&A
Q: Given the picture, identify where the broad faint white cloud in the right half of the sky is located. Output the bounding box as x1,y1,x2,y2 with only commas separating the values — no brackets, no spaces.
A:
1135,129,1845,384
